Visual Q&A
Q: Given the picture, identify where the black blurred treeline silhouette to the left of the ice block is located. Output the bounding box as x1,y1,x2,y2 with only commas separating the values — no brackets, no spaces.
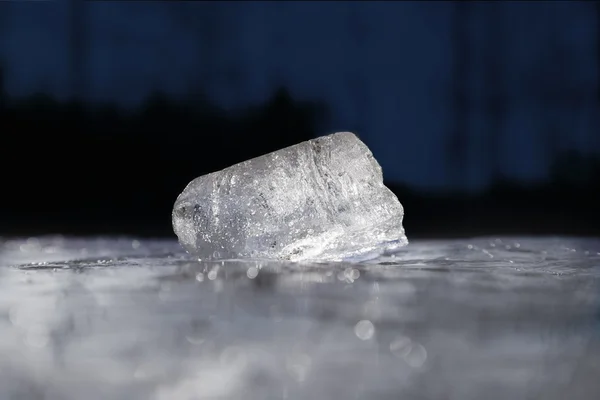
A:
0,89,327,235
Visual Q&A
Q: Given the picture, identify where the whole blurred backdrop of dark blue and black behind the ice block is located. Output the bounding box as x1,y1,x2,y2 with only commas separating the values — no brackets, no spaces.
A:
0,0,600,238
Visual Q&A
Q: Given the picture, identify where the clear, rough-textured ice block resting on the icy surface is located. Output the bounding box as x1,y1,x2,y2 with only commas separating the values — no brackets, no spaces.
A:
173,132,408,261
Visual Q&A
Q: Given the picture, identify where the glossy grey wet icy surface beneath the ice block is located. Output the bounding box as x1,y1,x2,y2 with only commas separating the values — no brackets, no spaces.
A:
0,238,600,399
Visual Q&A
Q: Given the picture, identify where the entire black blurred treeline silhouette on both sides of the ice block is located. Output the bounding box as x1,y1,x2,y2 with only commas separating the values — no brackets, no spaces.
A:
0,74,600,237
